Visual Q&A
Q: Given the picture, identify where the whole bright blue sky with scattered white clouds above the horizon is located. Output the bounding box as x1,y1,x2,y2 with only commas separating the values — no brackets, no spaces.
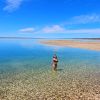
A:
0,0,100,38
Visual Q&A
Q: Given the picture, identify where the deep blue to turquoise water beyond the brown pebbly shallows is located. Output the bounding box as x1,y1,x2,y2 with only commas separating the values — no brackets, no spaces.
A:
0,39,100,76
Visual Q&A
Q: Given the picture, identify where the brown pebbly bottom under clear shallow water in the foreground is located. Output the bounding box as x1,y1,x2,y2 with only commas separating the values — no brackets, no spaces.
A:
0,66,100,100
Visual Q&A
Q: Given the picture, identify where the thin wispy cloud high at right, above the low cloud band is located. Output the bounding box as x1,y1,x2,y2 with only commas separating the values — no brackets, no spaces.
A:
65,14,100,24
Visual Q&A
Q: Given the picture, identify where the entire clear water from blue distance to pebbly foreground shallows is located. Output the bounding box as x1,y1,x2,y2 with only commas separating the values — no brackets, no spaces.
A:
0,39,100,100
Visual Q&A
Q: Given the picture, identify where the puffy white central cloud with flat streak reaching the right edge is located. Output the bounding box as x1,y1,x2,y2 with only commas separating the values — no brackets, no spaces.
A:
36,25,100,33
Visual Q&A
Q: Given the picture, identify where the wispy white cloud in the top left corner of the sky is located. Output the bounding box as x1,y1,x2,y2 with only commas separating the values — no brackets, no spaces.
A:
3,0,25,12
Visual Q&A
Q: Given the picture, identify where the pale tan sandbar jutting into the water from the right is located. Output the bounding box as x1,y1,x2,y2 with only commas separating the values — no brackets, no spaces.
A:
40,39,100,51
